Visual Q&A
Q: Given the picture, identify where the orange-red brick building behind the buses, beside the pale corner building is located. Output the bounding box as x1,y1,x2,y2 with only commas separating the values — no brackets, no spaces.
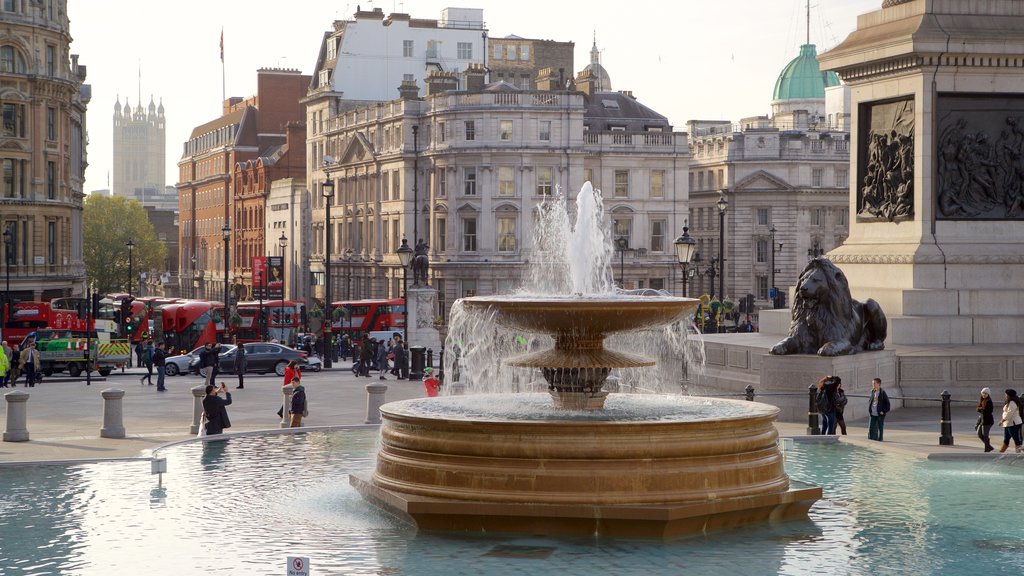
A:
177,69,310,299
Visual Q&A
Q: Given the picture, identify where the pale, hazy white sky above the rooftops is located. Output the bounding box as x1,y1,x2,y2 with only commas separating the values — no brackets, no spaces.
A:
68,0,882,192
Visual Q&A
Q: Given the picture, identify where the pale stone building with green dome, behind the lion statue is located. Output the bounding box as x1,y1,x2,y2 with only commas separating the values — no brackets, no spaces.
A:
688,44,850,315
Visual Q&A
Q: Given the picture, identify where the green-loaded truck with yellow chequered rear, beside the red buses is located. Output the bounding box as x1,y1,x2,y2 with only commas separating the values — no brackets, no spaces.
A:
36,329,131,378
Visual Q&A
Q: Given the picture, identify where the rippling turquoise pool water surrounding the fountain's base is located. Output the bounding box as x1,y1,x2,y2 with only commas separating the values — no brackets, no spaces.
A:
0,428,1024,576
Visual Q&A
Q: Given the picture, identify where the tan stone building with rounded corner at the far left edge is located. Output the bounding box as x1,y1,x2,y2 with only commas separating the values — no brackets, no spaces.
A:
0,0,91,300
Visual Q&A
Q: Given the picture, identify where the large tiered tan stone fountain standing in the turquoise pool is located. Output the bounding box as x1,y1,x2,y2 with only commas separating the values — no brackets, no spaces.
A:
350,182,821,538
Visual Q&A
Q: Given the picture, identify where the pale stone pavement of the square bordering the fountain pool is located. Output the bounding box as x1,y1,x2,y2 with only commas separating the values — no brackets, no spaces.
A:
0,363,1013,464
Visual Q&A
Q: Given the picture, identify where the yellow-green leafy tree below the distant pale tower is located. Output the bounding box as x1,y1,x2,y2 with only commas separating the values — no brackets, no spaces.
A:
83,194,167,294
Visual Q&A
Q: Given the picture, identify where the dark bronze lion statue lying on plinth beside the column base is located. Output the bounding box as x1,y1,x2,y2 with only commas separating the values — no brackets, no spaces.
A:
770,258,889,356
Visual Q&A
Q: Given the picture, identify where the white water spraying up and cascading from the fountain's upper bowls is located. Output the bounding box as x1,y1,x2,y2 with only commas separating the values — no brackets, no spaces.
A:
442,181,703,394
